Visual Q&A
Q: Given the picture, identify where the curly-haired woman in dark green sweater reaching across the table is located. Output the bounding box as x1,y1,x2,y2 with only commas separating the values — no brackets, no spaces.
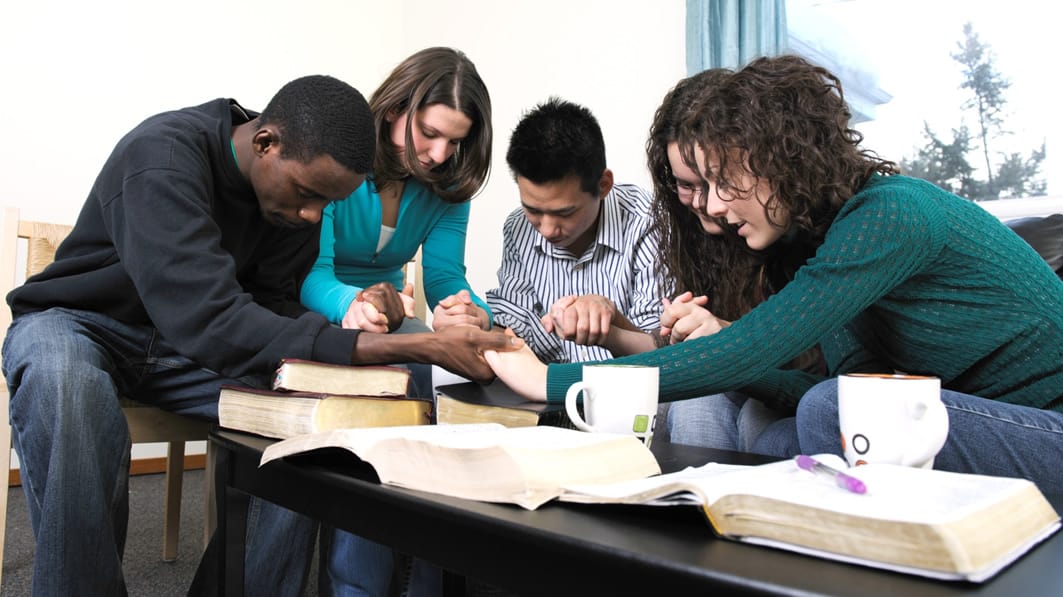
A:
486,56,1063,492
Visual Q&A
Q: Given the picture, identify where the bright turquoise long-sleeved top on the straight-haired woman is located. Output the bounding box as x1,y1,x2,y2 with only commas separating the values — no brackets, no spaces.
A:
300,178,491,324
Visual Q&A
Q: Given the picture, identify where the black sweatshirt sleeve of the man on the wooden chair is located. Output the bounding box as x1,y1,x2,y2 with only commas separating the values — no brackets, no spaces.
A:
101,160,356,376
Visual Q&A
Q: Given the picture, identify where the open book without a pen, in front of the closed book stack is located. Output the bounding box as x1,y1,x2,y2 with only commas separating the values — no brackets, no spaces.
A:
261,423,660,509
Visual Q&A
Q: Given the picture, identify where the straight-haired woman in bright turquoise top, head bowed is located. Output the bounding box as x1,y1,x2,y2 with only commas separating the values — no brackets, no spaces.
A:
302,48,492,595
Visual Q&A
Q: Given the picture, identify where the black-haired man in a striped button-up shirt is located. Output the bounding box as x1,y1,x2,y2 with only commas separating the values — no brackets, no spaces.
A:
487,98,661,362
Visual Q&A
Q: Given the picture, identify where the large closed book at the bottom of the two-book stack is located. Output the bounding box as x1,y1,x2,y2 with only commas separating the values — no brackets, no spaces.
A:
218,386,432,439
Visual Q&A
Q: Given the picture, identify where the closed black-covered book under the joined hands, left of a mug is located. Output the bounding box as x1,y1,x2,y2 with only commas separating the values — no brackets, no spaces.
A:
436,379,573,428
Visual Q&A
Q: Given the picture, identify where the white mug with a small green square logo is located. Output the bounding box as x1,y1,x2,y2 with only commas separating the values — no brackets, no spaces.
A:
564,364,660,445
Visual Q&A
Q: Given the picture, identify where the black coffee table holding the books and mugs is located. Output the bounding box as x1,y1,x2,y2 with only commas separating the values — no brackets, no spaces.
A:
209,429,1063,597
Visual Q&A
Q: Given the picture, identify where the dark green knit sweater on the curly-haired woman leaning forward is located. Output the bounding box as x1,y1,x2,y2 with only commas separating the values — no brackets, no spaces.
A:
546,176,1063,412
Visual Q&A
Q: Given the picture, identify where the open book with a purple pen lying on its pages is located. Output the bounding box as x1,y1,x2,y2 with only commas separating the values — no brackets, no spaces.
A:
559,455,1060,582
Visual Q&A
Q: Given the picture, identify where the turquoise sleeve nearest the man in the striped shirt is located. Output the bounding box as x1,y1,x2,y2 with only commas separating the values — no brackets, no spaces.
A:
421,201,493,321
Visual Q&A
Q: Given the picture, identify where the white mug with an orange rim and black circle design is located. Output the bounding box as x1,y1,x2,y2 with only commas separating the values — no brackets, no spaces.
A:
838,374,948,468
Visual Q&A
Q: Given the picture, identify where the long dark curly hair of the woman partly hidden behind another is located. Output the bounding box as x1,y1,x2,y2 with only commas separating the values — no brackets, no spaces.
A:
646,68,770,321
